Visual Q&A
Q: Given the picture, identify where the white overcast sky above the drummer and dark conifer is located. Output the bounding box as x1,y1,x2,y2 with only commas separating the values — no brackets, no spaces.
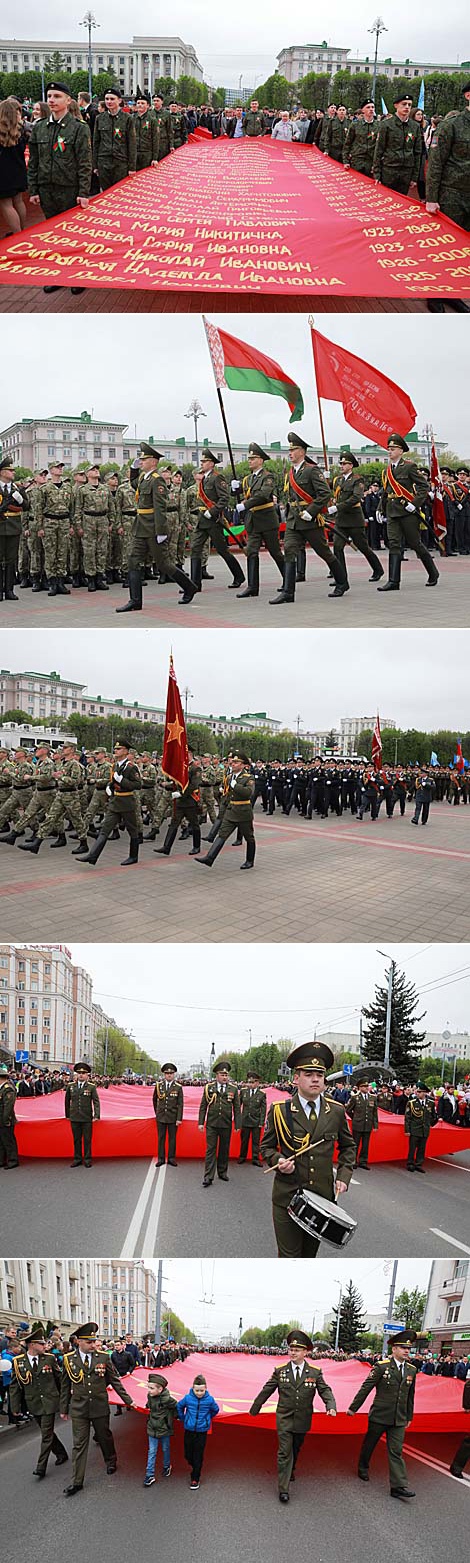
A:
64,930,470,1069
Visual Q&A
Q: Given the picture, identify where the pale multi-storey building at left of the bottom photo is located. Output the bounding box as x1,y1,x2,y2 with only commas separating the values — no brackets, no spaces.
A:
0,1258,156,1339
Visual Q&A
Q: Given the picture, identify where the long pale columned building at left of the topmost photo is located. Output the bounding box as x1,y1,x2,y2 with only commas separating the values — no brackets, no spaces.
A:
0,33,203,97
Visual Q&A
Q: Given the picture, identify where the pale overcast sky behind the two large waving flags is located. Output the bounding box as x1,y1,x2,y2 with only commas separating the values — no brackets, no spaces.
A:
0,314,470,458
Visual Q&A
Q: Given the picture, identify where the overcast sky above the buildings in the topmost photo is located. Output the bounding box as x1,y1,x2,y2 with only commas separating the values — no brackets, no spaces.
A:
2,0,468,86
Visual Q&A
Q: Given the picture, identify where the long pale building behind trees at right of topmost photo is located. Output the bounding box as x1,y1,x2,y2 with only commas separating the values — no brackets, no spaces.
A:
276,39,468,81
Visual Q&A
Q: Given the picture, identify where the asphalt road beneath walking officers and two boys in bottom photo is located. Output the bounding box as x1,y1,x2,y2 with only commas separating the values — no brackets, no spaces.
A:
0,1411,470,1563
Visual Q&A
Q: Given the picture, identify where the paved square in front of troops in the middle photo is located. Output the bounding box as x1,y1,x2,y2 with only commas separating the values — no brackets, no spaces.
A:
0,803,470,944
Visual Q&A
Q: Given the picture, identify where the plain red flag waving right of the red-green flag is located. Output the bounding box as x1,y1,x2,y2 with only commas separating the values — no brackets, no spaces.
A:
311,324,417,445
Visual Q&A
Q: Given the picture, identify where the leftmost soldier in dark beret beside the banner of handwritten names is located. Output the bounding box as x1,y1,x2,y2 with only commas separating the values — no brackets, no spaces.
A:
28,81,91,220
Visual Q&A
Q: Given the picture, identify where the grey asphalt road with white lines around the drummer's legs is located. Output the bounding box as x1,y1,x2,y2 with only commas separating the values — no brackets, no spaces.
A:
0,1152,470,1258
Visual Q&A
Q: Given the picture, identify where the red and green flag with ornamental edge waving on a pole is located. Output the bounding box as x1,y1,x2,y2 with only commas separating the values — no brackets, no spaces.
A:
203,316,303,424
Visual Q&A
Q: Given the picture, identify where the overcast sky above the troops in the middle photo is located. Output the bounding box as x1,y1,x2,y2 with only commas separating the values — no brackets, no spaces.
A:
0,628,470,731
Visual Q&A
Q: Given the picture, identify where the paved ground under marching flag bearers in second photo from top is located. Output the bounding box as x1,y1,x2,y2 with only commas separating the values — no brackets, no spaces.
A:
0,549,470,633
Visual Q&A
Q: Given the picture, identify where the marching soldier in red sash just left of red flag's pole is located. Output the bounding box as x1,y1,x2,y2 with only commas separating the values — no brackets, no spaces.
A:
270,435,348,608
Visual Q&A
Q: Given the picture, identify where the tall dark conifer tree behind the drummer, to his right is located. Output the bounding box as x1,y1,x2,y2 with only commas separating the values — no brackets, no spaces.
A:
362,961,426,1085
